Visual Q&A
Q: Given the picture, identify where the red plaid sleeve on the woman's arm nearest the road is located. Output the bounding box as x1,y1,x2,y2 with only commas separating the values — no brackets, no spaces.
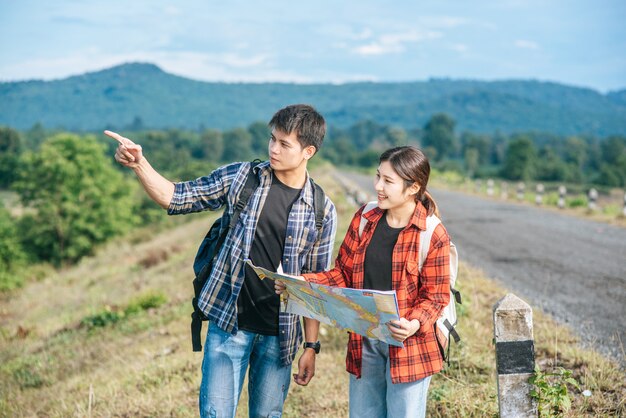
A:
408,224,450,337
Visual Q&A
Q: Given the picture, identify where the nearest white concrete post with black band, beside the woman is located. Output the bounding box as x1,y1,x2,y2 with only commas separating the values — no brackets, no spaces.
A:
493,293,537,418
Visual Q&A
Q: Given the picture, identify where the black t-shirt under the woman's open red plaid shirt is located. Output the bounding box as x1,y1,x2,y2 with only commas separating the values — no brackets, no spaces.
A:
363,214,404,290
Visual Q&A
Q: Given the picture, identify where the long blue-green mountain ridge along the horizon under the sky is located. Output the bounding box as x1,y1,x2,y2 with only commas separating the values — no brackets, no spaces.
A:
0,63,626,136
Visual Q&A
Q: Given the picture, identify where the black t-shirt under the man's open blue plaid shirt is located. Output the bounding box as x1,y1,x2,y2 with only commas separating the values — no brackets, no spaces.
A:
237,176,301,335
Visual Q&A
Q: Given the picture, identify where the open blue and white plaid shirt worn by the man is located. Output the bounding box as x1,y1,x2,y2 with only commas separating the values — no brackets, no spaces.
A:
167,161,337,364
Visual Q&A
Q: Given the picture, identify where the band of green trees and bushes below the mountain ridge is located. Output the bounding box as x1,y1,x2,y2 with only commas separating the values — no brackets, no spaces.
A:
0,114,626,289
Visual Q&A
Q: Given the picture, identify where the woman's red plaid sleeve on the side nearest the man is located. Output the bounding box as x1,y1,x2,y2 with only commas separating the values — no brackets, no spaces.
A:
304,209,362,287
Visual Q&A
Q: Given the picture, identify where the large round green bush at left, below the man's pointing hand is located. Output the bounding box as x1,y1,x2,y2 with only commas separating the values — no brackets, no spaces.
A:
13,133,138,266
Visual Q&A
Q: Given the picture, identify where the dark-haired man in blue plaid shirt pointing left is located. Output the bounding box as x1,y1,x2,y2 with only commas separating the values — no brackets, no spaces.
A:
105,105,337,417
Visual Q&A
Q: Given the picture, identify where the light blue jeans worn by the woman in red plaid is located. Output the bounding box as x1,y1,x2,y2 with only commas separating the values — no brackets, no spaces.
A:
350,337,431,418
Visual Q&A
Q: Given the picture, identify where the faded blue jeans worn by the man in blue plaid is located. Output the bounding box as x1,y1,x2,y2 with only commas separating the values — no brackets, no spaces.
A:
200,323,291,418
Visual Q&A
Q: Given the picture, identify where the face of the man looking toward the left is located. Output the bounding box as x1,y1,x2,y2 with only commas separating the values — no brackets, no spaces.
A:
268,129,315,171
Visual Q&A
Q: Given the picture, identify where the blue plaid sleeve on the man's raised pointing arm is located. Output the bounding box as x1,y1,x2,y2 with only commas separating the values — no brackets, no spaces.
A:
167,163,247,215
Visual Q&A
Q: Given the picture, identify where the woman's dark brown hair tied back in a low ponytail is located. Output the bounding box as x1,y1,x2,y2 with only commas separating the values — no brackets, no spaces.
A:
378,145,439,216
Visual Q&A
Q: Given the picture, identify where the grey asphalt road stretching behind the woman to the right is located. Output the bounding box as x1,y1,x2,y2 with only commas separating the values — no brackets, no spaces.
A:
342,173,626,366
